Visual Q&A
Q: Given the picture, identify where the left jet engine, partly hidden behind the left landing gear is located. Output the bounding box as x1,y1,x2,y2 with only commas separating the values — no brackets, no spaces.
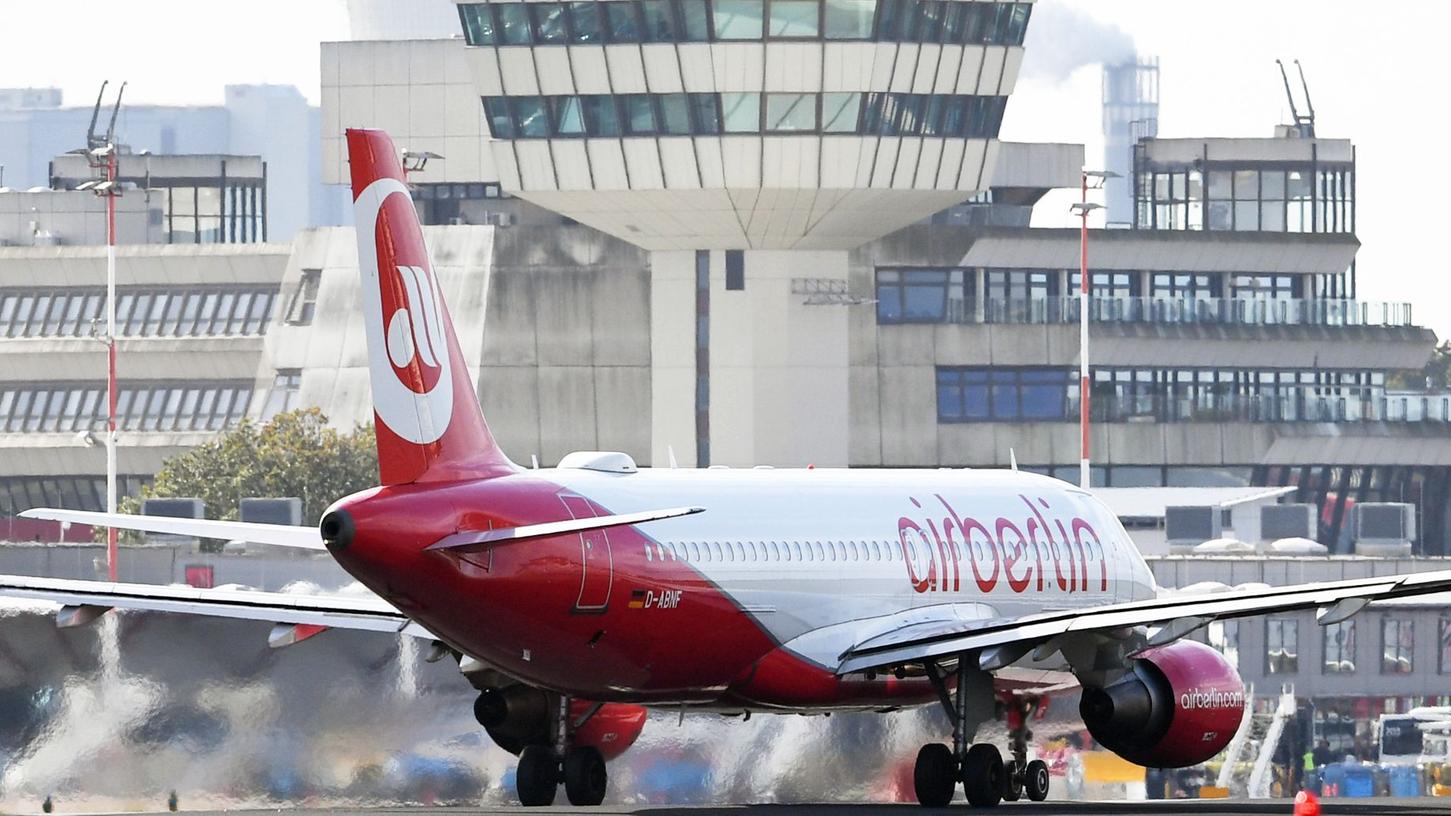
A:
473,684,646,759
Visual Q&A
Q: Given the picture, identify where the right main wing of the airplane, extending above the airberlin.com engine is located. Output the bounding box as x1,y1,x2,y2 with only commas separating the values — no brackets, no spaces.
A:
836,571,1451,674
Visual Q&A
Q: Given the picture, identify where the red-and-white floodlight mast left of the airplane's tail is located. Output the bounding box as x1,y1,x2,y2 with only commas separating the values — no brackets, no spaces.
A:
86,80,126,582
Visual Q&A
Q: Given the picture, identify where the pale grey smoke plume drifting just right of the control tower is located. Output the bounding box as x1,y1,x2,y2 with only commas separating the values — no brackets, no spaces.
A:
1023,0,1136,83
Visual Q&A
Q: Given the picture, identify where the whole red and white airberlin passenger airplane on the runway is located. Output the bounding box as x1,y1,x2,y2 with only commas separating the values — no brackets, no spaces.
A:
11,129,1451,807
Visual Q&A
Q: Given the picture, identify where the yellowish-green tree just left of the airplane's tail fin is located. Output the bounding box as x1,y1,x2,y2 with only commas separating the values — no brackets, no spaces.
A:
120,408,377,524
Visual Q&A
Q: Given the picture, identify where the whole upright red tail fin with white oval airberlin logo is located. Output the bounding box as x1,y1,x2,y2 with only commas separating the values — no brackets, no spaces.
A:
347,129,514,485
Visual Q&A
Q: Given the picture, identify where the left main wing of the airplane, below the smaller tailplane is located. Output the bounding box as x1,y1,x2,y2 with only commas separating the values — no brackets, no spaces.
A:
0,575,434,646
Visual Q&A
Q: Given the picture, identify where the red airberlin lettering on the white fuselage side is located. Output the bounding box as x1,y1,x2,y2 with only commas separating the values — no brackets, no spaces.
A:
897,495,1109,594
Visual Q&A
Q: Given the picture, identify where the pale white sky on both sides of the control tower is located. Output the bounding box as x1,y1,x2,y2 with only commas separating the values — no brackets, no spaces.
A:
0,0,1451,337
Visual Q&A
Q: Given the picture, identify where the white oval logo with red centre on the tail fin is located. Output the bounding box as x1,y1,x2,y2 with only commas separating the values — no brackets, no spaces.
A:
353,179,454,444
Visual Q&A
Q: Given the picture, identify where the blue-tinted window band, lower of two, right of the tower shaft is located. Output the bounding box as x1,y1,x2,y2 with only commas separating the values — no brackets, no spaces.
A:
937,367,1069,423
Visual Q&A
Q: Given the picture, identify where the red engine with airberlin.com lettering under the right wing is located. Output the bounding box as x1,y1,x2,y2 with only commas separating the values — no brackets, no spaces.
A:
1078,640,1245,768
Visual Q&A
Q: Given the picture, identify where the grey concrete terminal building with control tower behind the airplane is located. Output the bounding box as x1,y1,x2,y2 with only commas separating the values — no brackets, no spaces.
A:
0,0,1451,766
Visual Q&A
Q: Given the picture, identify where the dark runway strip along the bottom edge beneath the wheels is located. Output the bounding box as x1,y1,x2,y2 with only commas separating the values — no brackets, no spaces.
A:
116,797,1451,816
